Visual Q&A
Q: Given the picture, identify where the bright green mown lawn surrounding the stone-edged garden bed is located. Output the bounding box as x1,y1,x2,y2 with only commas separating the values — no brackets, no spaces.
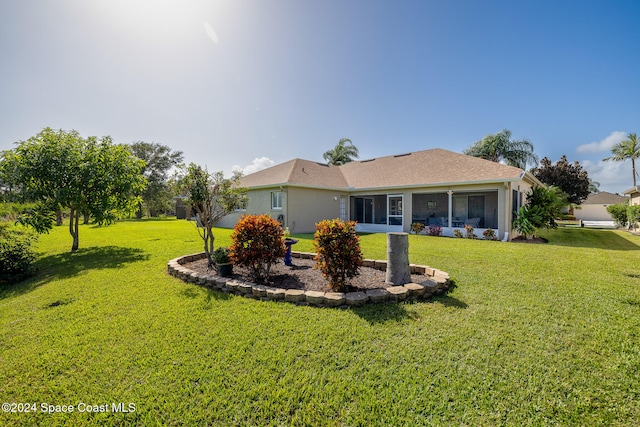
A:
0,220,640,426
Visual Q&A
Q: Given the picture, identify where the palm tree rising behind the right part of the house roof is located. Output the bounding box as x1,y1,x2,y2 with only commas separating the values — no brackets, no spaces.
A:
464,129,538,169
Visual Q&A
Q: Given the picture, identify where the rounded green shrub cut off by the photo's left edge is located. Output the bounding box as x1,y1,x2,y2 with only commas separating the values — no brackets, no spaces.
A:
0,224,37,285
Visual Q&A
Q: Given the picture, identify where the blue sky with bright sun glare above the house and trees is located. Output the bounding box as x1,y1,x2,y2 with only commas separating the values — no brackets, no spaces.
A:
0,0,640,192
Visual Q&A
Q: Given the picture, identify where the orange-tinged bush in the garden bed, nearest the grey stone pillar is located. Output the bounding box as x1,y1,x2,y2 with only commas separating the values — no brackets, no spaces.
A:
313,219,362,292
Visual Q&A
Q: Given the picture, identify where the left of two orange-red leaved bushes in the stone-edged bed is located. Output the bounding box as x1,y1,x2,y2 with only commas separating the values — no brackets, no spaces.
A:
229,214,285,281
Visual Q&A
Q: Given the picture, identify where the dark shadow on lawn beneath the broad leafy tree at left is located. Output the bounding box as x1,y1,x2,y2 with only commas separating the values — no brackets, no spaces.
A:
0,246,149,299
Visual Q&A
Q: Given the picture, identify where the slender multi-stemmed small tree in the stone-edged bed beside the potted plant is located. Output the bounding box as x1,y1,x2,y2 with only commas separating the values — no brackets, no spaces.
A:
182,163,246,269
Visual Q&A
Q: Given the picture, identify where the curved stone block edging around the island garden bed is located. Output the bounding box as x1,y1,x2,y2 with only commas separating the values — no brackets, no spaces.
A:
167,252,452,307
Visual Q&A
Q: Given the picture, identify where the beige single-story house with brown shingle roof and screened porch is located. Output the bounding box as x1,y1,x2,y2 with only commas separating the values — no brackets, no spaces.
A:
219,149,542,239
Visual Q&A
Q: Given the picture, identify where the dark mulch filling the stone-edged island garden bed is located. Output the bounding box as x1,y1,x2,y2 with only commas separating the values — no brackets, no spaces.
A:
184,258,429,292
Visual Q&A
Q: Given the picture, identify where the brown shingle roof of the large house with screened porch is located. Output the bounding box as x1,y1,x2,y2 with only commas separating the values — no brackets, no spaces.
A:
242,148,524,189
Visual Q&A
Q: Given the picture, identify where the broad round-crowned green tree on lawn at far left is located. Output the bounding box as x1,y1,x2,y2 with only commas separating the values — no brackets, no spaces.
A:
0,128,145,251
